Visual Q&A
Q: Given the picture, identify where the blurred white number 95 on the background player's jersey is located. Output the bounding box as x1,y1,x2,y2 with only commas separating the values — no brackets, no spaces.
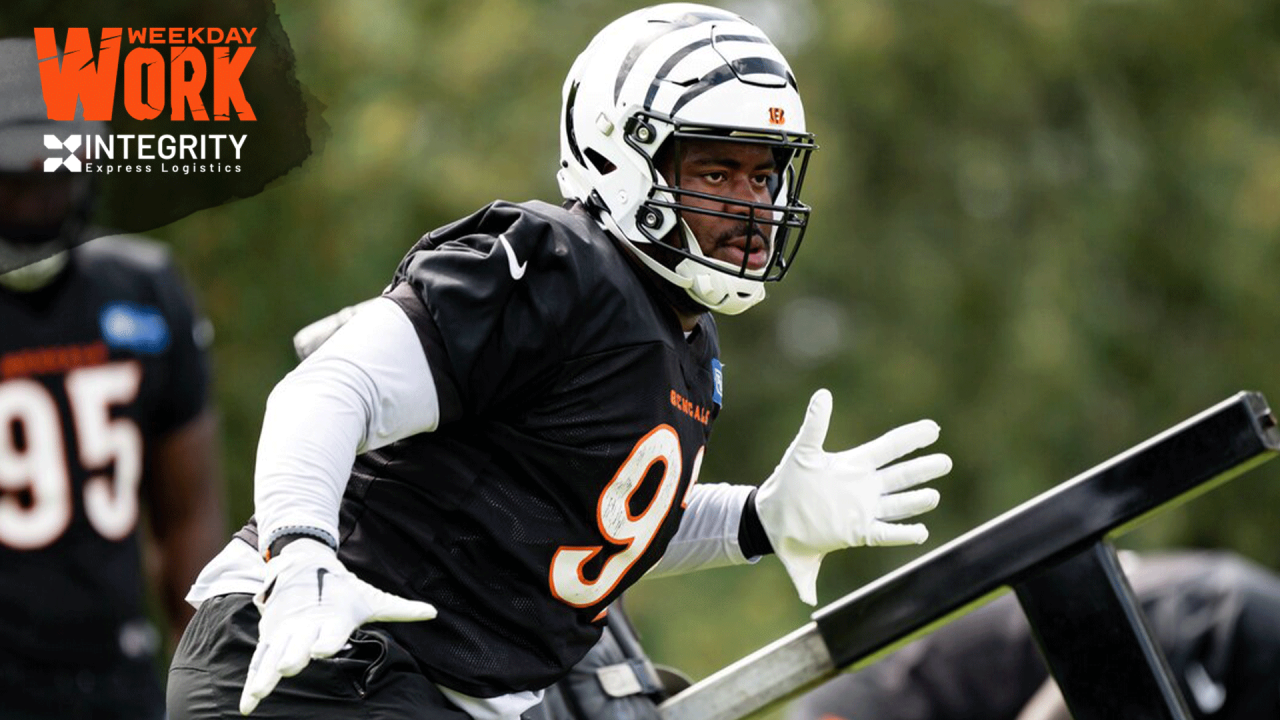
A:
0,363,142,550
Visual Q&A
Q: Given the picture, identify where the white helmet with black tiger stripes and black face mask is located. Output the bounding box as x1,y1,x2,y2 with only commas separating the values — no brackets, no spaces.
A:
557,3,817,315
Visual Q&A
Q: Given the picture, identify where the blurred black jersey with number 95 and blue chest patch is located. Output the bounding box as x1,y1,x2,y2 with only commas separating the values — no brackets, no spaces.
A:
0,237,207,665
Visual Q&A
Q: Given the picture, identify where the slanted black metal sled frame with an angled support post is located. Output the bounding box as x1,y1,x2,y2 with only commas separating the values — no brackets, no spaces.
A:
659,392,1280,720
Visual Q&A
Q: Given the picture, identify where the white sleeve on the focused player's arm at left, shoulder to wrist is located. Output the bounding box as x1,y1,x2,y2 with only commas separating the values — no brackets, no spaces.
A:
253,300,440,550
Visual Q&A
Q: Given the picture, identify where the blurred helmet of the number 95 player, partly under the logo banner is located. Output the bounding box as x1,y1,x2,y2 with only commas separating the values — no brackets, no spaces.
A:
0,38,106,291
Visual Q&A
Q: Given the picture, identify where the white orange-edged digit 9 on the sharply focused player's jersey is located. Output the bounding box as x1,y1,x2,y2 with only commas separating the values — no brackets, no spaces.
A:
550,424,701,607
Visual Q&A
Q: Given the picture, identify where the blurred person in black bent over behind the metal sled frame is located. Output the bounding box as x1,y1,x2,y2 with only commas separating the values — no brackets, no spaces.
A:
788,551,1280,720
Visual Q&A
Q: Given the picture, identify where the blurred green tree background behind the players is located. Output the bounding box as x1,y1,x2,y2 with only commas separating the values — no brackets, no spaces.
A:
124,0,1280,707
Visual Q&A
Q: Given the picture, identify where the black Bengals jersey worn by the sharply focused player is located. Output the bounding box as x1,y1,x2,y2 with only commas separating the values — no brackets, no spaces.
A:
340,202,721,697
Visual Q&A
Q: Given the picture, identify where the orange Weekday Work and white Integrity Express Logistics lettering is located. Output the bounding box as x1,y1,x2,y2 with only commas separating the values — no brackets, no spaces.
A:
36,28,257,174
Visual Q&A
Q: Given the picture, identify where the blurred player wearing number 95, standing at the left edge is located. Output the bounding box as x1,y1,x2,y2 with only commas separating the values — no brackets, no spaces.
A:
0,40,225,720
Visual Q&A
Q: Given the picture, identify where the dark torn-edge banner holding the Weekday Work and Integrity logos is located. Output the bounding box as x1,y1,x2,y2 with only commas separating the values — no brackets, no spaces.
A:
0,0,329,236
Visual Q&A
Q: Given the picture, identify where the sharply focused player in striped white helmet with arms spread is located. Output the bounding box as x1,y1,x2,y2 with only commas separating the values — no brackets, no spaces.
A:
169,4,951,720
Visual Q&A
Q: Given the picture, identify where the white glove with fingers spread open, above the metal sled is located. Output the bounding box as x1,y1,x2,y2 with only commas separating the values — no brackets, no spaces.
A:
755,388,951,605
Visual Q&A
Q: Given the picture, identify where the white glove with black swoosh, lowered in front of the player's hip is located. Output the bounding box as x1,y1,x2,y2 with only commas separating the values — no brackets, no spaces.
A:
241,538,435,715
